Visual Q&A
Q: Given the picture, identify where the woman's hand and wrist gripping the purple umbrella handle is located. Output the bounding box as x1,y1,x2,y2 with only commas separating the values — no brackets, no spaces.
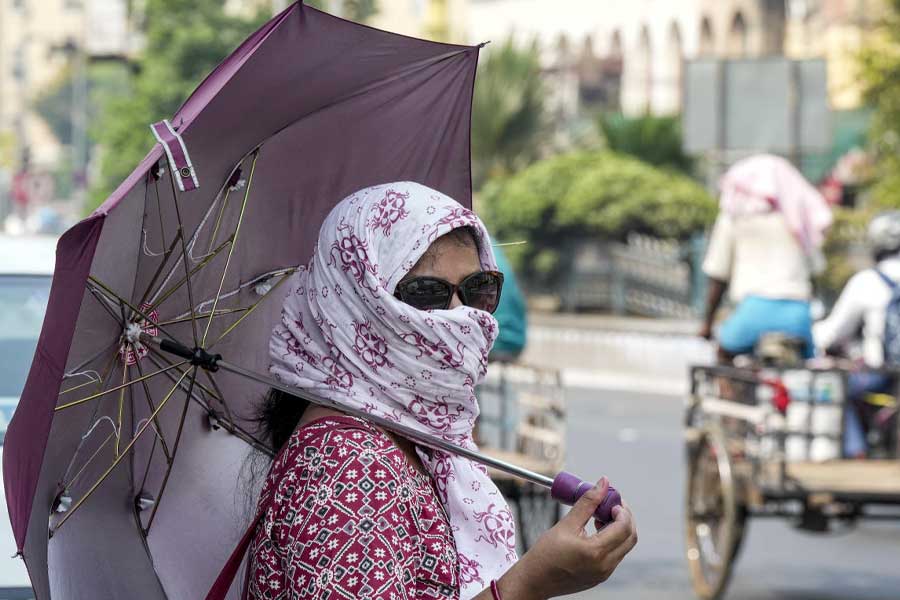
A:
487,477,637,600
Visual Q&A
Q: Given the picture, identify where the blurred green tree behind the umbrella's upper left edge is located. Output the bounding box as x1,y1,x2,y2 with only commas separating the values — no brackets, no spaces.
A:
91,0,269,211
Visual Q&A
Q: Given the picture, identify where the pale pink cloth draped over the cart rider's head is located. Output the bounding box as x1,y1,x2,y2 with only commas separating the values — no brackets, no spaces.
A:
719,154,832,268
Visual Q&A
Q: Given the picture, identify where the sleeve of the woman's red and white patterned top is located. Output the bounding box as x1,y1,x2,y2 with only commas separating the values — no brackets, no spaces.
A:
255,430,418,600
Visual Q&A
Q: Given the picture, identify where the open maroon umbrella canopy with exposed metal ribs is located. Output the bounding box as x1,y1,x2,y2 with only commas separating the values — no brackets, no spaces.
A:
3,3,478,600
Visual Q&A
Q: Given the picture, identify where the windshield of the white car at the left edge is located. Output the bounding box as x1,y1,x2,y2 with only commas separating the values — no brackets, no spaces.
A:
0,275,51,441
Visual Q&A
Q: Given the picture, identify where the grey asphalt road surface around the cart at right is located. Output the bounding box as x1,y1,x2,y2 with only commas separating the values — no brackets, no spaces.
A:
567,389,900,600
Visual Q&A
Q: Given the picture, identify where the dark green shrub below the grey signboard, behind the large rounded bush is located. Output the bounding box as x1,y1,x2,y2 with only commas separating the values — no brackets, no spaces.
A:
598,114,694,173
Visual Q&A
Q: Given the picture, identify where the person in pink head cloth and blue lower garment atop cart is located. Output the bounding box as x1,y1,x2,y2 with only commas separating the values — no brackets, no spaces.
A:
700,154,832,360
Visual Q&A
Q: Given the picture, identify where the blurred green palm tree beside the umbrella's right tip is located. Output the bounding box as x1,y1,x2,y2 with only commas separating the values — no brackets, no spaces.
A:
472,38,546,189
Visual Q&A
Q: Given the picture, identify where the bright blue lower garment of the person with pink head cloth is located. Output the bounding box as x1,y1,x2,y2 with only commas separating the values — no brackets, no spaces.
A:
719,296,815,358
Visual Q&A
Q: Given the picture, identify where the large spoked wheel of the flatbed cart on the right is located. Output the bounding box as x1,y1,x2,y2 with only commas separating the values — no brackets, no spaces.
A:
685,428,744,600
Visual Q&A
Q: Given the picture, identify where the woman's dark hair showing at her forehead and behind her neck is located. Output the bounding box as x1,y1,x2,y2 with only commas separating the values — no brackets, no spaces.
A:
255,225,480,452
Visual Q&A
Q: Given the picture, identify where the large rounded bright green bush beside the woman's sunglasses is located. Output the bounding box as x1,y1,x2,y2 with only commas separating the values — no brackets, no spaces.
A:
481,151,717,279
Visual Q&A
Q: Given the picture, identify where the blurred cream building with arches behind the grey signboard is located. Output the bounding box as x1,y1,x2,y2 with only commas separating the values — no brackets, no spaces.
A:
467,0,786,114
